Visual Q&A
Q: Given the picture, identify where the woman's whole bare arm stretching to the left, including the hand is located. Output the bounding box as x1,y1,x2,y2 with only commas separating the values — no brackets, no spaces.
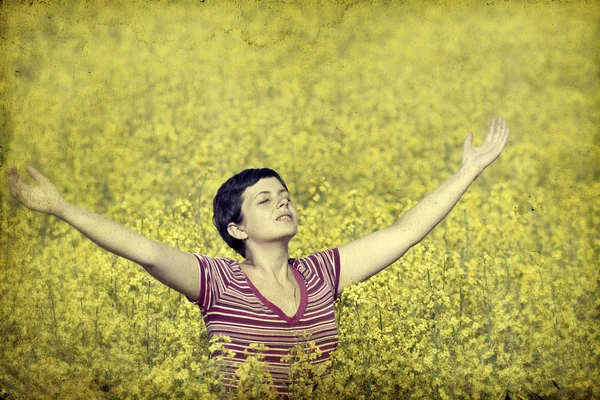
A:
8,167,199,299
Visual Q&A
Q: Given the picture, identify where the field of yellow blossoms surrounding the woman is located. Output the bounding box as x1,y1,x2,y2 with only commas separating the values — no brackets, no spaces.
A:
0,0,600,399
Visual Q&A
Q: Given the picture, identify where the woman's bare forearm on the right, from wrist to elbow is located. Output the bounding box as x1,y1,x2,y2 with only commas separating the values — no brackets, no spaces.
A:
394,167,481,244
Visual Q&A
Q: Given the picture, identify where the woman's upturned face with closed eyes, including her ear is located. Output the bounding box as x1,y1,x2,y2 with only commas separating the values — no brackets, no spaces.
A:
237,177,298,243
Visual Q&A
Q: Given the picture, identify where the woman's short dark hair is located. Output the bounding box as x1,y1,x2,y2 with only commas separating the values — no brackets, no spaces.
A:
213,168,288,257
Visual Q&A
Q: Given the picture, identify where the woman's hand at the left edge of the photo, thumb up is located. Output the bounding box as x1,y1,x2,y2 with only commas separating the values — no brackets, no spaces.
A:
7,166,65,216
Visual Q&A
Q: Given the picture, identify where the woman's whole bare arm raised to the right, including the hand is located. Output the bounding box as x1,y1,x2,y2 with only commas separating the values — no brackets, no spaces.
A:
338,117,510,294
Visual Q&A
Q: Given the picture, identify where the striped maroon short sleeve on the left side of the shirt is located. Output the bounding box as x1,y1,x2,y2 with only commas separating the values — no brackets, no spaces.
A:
186,253,230,310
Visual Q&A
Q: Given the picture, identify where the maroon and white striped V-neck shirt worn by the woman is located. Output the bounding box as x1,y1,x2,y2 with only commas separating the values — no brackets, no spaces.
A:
187,248,340,394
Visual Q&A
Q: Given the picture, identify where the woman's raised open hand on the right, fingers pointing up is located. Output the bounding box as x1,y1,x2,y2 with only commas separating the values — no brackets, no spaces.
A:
462,117,510,174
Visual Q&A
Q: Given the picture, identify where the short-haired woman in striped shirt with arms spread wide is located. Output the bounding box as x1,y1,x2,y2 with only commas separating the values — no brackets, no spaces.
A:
8,117,509,393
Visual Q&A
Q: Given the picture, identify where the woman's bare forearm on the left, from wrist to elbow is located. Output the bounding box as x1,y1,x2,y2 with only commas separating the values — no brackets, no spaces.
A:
54,201,157,266
